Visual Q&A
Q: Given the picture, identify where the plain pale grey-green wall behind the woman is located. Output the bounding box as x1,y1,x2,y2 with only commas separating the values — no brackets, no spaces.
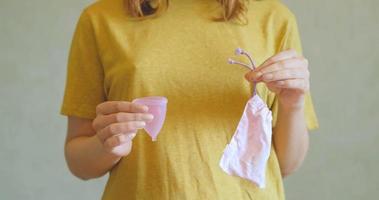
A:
0,0,379,200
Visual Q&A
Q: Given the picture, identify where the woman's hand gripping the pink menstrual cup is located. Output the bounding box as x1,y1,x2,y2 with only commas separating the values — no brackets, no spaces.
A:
92,101,154,157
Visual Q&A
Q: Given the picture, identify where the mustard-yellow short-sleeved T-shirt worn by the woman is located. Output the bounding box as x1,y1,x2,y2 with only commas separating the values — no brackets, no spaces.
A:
61,0,318,200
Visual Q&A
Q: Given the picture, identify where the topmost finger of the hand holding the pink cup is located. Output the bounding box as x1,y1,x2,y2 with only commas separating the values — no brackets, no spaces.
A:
96,101,149,115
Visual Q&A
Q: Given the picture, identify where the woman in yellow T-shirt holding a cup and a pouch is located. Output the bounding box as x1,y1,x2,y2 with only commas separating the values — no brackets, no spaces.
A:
61,0,318,200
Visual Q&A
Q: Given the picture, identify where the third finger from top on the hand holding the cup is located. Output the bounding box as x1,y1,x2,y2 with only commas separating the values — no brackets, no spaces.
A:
97,121,146,142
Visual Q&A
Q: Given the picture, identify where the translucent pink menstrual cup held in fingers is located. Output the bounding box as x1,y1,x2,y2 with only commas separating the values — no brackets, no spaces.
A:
132,96,167,141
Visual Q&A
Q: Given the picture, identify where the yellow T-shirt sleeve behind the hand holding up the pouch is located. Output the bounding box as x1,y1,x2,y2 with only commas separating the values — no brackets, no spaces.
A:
271,13,319,130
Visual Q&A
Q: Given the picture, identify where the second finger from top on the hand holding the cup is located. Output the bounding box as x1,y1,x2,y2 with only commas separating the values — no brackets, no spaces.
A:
92,112,154,130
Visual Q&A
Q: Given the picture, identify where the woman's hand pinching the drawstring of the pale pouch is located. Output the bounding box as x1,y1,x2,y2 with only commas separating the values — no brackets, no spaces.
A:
245,50,310,108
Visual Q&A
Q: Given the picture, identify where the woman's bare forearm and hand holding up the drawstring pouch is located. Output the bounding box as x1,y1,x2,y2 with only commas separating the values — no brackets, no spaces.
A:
245,50,310,176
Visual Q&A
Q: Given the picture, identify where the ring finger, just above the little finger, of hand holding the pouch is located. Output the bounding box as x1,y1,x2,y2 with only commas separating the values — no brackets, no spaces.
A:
261,68,308,83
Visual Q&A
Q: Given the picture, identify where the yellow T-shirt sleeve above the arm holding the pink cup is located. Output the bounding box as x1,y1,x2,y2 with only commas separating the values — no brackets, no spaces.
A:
60,10,105,119
